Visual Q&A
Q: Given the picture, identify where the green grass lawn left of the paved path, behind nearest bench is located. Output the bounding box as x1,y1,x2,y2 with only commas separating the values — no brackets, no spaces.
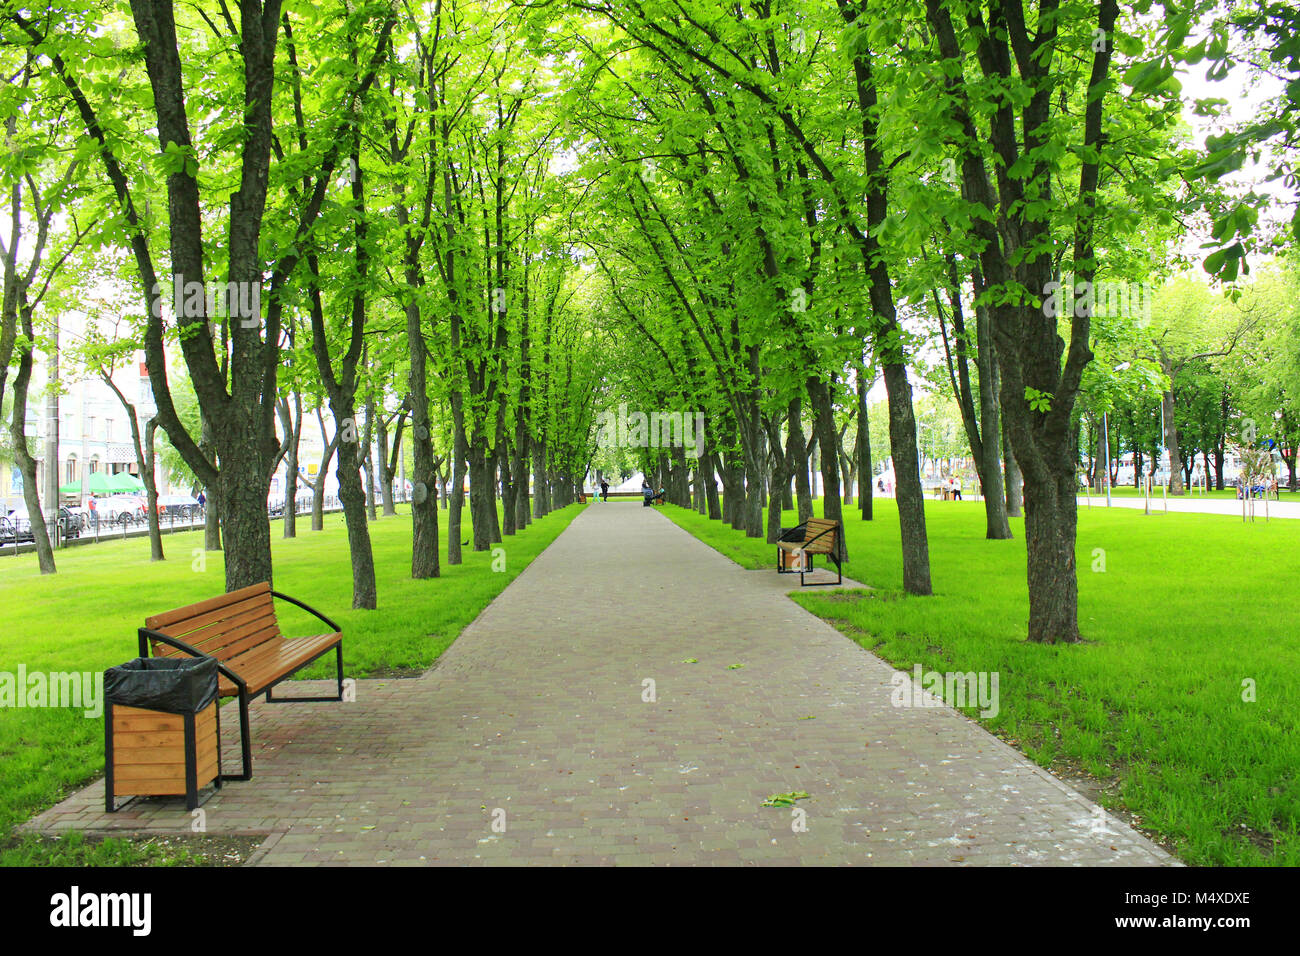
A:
0,505,581,865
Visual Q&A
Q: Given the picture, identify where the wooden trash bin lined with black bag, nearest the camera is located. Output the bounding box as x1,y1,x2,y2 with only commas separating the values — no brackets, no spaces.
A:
104,658,221,813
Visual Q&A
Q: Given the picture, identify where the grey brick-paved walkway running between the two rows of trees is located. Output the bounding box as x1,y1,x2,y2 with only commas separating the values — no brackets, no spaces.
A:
29,502,1171,865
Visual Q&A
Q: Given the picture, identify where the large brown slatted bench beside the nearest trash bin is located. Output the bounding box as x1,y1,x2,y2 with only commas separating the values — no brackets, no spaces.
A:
139,583,343,780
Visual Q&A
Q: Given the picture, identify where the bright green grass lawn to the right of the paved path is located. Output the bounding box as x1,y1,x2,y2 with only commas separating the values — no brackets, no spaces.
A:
664,499,1300,866
